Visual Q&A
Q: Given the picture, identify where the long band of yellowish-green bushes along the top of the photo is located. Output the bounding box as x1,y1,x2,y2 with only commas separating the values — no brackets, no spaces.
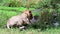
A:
1,0,51,8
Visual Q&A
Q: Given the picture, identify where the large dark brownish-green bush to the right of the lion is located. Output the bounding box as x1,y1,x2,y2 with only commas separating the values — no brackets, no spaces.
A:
38,8,57,29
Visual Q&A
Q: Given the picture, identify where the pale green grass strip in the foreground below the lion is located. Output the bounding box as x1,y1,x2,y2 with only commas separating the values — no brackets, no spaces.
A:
0,28,60,34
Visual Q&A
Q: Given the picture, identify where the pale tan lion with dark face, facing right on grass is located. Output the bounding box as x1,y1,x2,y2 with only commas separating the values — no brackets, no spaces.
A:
6,10,33,29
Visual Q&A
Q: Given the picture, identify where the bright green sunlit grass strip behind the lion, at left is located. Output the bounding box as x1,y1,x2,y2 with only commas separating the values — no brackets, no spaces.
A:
0,6,34,11
